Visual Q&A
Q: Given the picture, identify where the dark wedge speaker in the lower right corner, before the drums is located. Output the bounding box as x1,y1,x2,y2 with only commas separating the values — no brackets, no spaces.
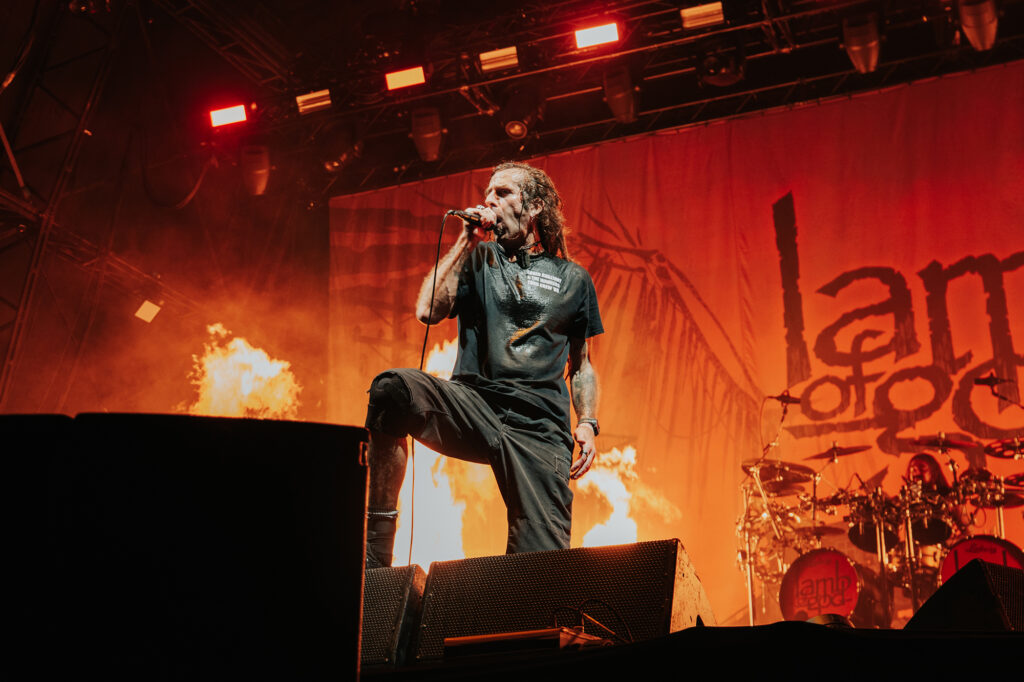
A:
903,559,1024,632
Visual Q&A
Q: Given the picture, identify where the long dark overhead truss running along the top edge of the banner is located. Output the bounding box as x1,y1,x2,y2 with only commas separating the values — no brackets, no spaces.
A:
330,3,1024,194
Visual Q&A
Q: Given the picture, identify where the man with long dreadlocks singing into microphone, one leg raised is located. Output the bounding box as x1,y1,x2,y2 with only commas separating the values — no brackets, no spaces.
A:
366,163,604,568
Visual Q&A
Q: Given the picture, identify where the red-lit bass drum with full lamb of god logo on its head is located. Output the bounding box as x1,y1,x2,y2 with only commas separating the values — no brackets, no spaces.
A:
778,549,890,627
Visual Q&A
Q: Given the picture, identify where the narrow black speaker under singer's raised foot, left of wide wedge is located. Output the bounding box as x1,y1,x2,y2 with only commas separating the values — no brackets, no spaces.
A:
359,565,427,670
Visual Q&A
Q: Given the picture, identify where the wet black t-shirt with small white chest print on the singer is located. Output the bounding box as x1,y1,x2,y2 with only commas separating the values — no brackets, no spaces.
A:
452,242,604,447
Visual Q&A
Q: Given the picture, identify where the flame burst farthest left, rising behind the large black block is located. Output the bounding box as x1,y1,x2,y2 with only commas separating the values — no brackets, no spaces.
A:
187,323,302,419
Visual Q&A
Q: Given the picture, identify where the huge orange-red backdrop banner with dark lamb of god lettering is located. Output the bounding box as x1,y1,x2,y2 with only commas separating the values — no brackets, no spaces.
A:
329,62,1024,623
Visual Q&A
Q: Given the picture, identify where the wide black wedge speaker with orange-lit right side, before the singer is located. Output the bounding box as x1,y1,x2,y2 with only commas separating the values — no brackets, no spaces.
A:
416,540,715,660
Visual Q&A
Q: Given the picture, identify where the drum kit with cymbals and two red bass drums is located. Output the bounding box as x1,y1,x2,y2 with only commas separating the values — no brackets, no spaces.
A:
736,433,1024,627
